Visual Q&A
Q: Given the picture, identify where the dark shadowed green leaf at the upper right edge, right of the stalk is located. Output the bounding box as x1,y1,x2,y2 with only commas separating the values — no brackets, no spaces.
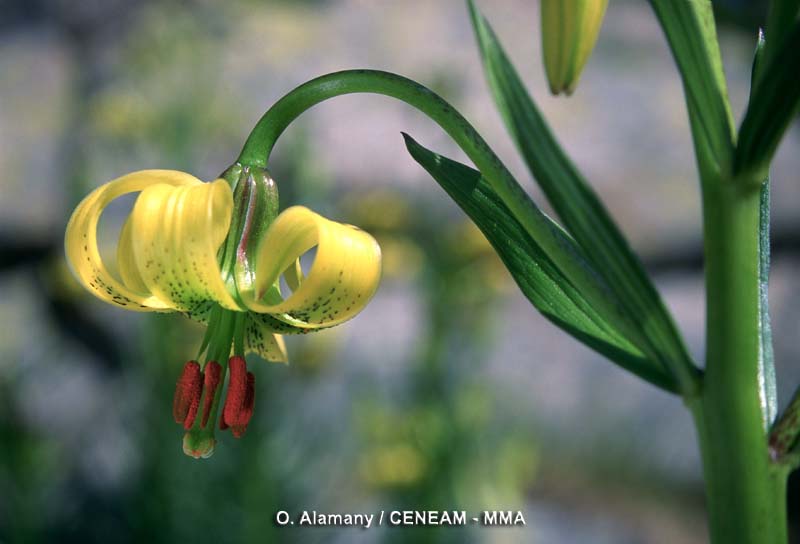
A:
735,20,800,183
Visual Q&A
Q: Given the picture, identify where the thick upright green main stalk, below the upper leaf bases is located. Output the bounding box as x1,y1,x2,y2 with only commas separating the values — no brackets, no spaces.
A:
687,179,788,544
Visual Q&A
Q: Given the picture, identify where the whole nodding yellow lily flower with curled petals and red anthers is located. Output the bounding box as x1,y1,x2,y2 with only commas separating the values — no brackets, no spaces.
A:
65,164,381,457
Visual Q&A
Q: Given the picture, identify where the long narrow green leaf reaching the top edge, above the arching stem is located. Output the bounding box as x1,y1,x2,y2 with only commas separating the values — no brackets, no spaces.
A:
472,2,696,392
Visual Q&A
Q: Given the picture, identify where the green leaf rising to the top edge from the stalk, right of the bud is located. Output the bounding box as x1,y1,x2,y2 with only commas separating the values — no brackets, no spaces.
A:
650,0,734,179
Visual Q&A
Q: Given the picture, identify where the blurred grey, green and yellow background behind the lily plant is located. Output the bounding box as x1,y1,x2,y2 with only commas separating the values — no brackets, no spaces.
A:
0,0,800,544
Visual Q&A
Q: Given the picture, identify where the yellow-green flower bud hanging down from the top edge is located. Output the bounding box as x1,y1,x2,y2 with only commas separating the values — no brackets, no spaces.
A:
542,0,608,95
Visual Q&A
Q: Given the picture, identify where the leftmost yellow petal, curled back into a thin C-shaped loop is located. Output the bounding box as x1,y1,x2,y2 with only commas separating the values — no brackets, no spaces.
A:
64,170,202,311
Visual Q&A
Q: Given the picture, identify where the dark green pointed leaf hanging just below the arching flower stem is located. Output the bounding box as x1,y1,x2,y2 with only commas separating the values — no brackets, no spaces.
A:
403,134,676,391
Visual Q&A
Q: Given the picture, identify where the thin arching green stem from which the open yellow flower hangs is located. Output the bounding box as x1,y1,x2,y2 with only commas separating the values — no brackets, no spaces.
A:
237,70,699,396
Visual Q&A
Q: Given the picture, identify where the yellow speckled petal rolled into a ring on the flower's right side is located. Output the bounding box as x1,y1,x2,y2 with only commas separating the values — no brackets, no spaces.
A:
240,206,381,329
